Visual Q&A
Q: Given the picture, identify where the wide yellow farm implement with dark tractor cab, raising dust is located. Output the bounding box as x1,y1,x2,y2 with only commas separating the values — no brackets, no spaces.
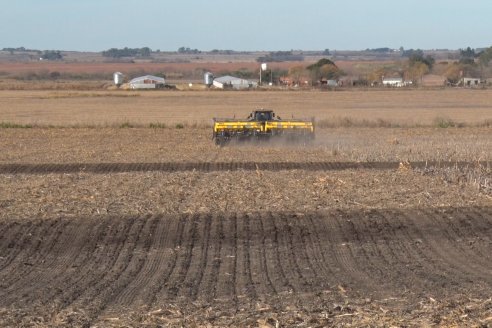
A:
213,109,314,145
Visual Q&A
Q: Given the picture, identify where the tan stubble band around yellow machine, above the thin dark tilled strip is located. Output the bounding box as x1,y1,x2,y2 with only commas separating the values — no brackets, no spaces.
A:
0,126,492,163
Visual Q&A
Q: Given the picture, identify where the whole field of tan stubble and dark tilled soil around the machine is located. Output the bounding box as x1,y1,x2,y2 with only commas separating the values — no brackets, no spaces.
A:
0,89,492,327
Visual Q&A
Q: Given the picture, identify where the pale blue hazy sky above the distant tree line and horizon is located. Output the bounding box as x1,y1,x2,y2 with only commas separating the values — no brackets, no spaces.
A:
0,0,492,51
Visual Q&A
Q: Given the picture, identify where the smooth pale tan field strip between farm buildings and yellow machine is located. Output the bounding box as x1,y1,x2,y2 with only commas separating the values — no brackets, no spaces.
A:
0,89,492,126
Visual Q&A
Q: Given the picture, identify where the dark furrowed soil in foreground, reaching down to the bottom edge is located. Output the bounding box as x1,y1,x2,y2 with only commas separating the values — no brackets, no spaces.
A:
0,207,492,326
